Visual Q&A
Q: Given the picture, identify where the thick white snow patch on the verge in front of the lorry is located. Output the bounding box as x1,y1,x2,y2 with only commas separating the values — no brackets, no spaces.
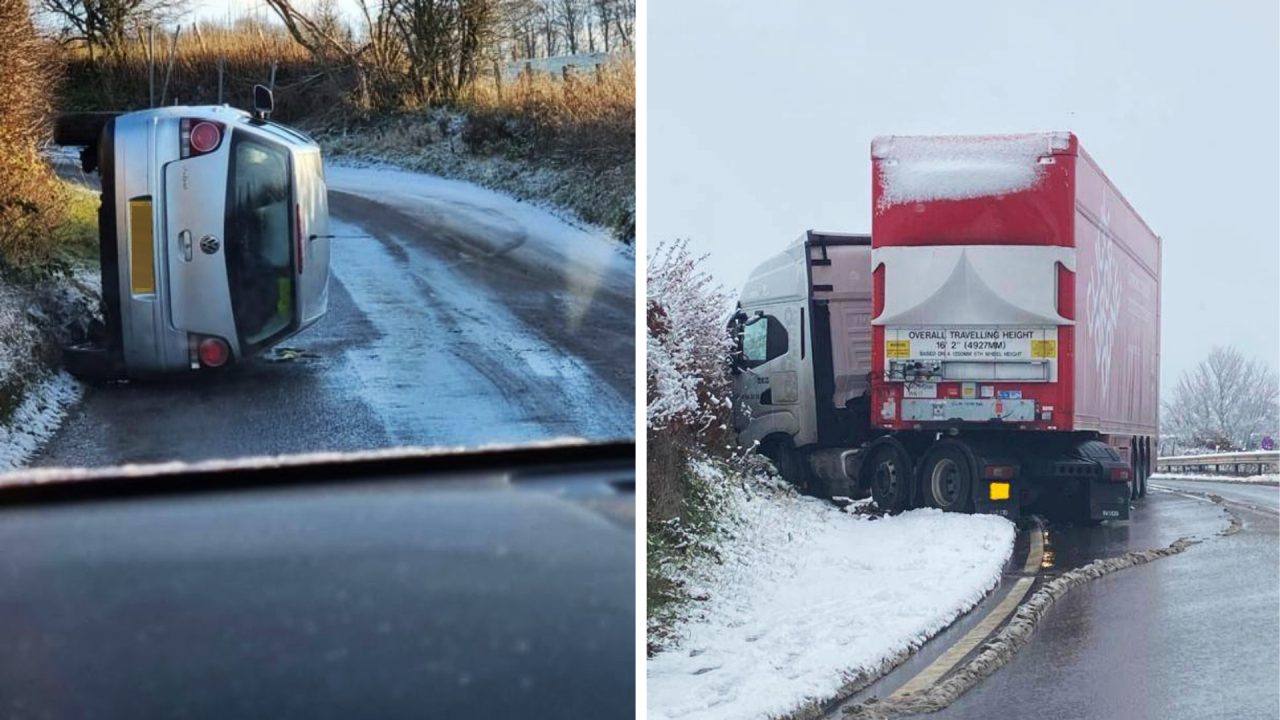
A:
648,464,1015,720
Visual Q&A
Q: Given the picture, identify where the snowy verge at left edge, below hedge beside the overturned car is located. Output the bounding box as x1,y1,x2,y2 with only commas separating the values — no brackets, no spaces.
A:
0,269,99,471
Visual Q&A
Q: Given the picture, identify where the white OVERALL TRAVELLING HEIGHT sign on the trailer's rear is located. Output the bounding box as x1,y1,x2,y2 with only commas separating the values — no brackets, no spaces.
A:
884,325,1057,360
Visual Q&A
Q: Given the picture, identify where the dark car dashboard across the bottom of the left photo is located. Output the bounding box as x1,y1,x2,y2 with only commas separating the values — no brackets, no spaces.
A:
0,443,635,719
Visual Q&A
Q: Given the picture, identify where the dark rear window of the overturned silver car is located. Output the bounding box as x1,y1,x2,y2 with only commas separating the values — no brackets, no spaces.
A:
227,132,294,351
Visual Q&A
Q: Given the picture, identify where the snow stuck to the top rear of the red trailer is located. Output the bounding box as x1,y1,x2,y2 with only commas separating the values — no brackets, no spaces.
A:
872,132,1071,208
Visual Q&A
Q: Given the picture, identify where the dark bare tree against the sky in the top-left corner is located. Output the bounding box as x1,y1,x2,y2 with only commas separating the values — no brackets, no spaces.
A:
37,0,187,58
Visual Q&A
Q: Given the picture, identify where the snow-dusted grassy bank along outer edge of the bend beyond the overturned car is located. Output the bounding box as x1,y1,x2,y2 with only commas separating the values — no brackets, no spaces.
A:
308,109,635,245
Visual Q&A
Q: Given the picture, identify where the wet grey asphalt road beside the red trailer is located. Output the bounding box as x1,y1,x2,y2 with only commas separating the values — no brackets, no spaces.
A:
921,480,1280,720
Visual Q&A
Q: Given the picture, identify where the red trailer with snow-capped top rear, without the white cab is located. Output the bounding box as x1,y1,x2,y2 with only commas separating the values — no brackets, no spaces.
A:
860,133,1161,519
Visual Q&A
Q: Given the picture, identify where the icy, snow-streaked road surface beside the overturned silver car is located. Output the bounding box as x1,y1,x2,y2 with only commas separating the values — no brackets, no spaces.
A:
33,165,635,466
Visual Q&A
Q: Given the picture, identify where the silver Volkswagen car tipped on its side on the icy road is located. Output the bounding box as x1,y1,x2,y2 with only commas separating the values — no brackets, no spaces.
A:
54,86,329,378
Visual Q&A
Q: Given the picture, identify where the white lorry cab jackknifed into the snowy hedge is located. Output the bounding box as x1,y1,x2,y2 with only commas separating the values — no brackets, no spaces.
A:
730,231,872,496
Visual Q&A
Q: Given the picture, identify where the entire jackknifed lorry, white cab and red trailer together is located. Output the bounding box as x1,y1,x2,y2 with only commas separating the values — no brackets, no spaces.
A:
731,133,1161,520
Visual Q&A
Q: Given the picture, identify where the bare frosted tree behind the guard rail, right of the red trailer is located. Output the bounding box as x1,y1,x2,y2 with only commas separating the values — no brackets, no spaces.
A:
1165,346,1280,450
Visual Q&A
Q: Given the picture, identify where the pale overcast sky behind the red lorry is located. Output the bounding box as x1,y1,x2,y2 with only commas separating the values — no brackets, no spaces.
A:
646,0,1280,391
